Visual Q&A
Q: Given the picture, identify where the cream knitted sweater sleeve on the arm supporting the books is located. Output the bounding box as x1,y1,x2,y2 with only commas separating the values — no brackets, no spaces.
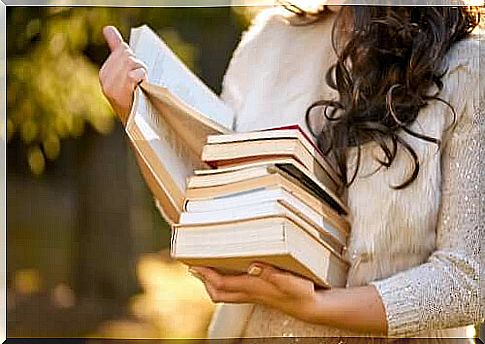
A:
370,37,484,337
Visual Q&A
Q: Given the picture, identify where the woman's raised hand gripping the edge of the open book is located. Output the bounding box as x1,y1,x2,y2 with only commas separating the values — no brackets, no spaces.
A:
99,26,147,125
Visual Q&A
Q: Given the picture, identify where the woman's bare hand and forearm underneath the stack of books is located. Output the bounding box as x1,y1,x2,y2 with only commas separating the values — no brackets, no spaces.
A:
189,263,387,336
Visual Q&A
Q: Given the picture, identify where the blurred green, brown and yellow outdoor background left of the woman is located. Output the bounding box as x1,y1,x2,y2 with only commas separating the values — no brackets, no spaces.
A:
7,7,258,338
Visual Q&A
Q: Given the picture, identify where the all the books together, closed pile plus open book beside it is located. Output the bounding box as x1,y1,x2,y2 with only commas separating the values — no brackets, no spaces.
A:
126,26,350,287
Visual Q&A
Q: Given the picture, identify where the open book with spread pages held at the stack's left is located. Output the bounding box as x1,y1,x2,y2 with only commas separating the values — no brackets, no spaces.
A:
126,26,234,224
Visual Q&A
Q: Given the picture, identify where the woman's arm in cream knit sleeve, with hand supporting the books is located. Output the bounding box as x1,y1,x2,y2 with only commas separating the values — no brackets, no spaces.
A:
192,37,485,336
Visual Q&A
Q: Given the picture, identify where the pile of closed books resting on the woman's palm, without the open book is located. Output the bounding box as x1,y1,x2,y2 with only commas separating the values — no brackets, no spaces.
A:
172,127,350,287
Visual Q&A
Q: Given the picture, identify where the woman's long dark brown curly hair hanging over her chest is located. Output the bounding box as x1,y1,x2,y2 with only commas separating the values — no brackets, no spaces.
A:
282,3,479,191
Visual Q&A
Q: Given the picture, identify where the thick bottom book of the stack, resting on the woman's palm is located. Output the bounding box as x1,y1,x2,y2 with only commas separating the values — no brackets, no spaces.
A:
171,216,349,288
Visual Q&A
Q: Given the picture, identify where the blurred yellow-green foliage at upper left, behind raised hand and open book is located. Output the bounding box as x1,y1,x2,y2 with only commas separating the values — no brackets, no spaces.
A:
7,7,248,175
